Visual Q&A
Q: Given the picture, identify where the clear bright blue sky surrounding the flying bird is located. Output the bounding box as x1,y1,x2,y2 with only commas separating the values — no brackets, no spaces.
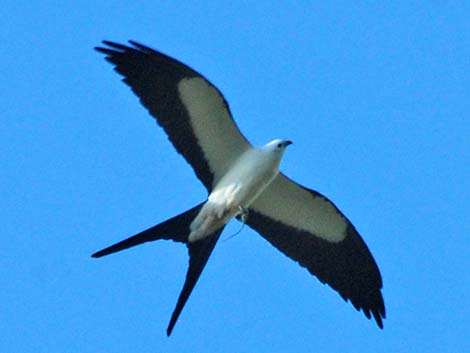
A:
0,0,470,353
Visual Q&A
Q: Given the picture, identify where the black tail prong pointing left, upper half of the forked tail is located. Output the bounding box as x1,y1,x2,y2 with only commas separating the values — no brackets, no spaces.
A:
91,203,203,258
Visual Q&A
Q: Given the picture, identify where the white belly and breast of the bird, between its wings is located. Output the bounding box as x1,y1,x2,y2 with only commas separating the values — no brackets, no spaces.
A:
189,149,279,242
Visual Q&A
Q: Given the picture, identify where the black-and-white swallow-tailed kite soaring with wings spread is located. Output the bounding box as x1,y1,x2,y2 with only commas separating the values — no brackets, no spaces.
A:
92,40,385,336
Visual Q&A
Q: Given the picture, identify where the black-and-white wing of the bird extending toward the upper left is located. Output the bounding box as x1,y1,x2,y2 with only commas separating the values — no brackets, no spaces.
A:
95,41,251,191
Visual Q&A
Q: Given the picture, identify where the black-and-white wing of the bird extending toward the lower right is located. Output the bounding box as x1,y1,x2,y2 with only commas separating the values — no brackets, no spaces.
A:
247,174,385,328
